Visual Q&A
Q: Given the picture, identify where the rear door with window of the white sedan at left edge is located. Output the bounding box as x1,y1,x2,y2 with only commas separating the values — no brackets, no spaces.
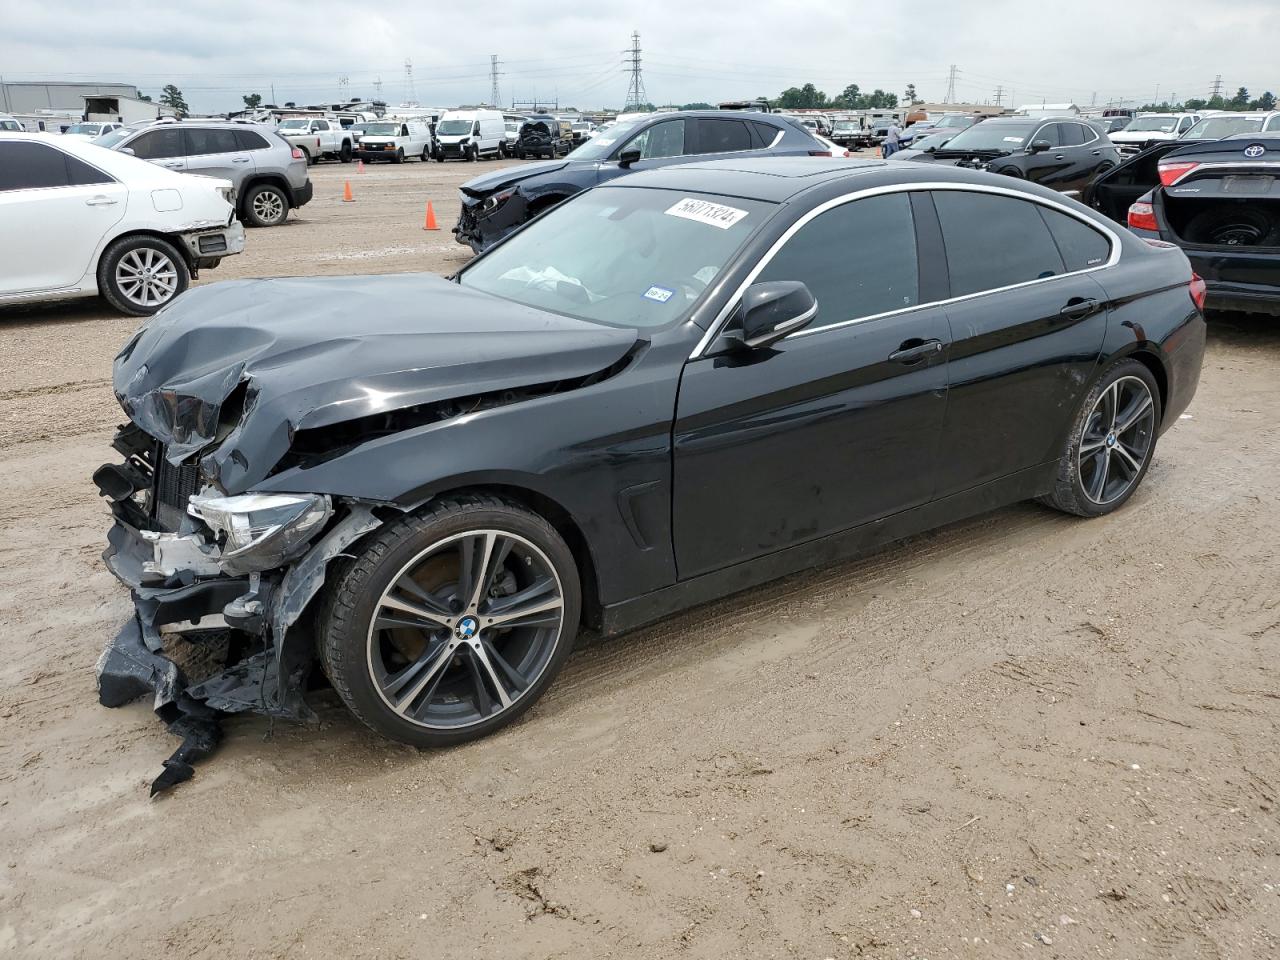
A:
0,138,128,296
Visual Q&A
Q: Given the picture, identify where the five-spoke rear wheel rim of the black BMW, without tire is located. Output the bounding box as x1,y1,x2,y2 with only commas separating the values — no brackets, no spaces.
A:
1076,376,1156,506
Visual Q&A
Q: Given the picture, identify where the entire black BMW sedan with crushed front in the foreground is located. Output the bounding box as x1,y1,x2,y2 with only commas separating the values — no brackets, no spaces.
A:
96,157,1204,787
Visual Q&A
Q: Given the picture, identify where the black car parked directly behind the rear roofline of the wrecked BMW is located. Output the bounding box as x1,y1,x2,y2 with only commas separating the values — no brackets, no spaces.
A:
914,116,1120,196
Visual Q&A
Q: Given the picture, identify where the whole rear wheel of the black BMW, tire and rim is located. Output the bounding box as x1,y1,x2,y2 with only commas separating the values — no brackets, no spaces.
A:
1043,360,1164,517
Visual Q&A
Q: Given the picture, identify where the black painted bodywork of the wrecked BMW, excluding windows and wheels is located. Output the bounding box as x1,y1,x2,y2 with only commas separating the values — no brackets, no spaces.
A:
95,160,1204,788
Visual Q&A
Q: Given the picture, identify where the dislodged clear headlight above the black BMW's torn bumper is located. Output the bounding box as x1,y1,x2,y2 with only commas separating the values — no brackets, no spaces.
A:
187,493,333,575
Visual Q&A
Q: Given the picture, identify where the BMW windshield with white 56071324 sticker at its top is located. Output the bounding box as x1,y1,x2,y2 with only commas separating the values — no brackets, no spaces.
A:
458,187,773,328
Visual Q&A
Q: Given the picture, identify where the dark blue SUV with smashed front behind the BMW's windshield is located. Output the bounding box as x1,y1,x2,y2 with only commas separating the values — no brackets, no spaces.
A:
453,110,831,253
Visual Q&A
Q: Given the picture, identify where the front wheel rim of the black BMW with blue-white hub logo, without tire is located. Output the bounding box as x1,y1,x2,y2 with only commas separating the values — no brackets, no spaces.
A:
367,530,564,730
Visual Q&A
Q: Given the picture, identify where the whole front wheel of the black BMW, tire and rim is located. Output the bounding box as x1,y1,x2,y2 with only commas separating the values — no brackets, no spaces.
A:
319,495,581,746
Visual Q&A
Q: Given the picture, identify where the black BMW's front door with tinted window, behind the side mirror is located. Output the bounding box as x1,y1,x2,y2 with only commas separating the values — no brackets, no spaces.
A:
673,192,950,579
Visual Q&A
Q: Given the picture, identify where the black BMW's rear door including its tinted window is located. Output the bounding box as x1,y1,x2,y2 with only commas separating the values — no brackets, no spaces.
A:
933,187,1112,497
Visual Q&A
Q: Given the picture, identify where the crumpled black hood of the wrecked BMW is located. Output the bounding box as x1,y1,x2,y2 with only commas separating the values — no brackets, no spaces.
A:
113,274,637,493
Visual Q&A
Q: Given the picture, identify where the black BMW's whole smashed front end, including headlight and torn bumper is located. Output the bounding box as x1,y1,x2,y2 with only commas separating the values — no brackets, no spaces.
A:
93,424,380,795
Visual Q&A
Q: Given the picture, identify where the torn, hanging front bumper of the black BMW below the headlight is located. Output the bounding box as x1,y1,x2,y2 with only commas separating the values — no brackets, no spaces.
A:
96,503,383,796
